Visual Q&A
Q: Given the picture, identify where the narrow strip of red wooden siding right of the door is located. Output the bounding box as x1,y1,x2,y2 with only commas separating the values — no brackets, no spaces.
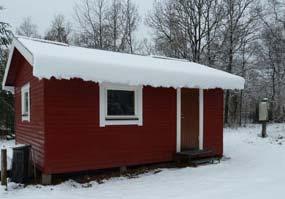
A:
204,89,224,156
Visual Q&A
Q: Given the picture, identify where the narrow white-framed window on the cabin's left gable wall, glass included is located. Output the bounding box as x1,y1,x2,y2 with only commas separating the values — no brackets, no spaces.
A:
21,83,30,121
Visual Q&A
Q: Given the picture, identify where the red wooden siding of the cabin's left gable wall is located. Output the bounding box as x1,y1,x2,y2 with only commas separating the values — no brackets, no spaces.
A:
10,50,44,168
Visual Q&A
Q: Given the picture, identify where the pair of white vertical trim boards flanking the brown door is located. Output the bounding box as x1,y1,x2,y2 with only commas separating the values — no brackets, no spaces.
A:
176,88,204,152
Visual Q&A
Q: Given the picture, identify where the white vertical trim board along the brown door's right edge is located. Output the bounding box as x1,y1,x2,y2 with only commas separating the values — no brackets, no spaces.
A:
199,89,204,150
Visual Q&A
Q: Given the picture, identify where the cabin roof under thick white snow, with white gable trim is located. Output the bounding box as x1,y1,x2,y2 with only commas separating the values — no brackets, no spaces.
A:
3,37,245,89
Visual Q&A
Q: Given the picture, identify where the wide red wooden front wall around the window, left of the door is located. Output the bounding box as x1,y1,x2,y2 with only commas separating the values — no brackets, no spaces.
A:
42,79,176,173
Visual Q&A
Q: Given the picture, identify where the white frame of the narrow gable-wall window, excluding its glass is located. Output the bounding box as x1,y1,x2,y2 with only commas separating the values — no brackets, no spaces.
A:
21,83,31,122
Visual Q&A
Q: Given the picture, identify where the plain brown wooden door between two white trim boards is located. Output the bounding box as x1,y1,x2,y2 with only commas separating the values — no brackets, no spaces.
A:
181,88,199,150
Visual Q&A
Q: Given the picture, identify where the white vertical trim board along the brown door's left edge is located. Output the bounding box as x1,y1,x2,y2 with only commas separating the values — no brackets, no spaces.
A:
176,88,181,152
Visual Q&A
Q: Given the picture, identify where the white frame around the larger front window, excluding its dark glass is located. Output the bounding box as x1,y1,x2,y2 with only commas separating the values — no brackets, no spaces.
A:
99,83,143,127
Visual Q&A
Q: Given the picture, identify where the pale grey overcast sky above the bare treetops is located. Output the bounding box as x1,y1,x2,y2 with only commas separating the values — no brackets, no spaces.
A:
0,0,153,34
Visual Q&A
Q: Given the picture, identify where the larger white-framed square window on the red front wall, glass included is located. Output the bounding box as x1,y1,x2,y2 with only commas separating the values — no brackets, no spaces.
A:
100,83,142,126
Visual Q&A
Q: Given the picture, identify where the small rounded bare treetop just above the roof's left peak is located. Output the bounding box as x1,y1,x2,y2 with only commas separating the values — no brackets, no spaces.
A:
16,17,41,38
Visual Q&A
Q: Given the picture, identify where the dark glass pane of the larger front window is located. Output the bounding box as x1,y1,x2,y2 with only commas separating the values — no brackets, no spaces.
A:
107,90,135,116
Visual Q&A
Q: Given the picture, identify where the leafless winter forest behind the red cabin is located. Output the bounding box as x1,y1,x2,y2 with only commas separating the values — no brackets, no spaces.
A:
0,0,285,132
